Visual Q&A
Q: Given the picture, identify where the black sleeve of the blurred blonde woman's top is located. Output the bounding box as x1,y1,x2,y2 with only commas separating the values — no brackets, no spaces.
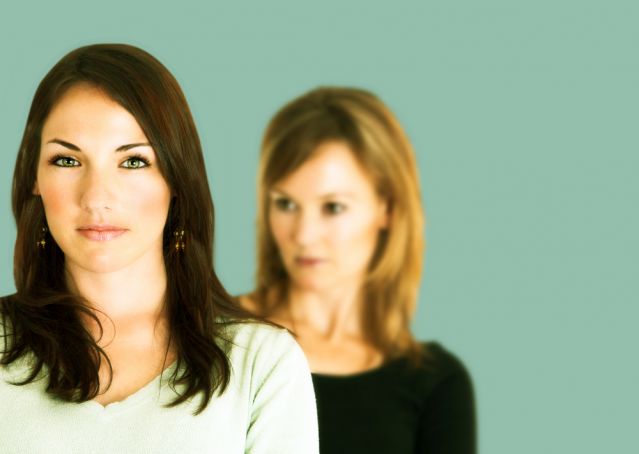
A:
417,355,477,454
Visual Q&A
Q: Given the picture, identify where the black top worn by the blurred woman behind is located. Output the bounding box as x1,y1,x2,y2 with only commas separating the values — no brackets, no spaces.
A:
313,342,476,454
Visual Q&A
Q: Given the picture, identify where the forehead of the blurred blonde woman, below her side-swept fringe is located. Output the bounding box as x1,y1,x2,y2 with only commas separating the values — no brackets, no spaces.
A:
273,142,375,197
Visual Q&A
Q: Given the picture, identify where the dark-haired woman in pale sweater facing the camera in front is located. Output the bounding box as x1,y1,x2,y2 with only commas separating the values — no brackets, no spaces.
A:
0,45,318,454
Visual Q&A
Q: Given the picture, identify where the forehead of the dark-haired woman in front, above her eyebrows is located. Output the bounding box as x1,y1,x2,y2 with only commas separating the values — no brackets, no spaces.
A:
42,83,144,139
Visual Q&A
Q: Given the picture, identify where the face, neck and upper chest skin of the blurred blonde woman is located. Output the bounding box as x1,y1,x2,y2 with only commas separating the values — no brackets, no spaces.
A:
244,142,388,375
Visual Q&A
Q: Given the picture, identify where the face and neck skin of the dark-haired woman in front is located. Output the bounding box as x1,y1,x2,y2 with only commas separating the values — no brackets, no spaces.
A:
33,84,175,405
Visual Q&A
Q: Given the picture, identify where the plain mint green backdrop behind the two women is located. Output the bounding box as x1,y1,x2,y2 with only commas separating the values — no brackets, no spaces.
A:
0,0,639,454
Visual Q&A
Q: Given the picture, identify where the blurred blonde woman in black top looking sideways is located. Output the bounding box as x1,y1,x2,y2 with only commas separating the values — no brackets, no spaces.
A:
242,88,476,454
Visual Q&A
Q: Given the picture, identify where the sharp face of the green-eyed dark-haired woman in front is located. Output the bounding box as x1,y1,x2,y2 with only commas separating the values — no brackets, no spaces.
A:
33,84,171,273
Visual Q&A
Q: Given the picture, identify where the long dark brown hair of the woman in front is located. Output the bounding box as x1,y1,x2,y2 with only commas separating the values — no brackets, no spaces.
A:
0,44,245,412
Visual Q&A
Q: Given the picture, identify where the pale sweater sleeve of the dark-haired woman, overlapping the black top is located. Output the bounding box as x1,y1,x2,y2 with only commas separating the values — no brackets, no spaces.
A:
246,331,319,454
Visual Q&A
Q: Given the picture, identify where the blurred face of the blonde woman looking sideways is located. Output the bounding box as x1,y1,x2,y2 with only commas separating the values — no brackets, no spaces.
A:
269,142,388,290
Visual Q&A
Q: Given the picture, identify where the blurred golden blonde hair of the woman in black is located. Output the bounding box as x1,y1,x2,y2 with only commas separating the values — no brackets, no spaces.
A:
251,87,424,358
